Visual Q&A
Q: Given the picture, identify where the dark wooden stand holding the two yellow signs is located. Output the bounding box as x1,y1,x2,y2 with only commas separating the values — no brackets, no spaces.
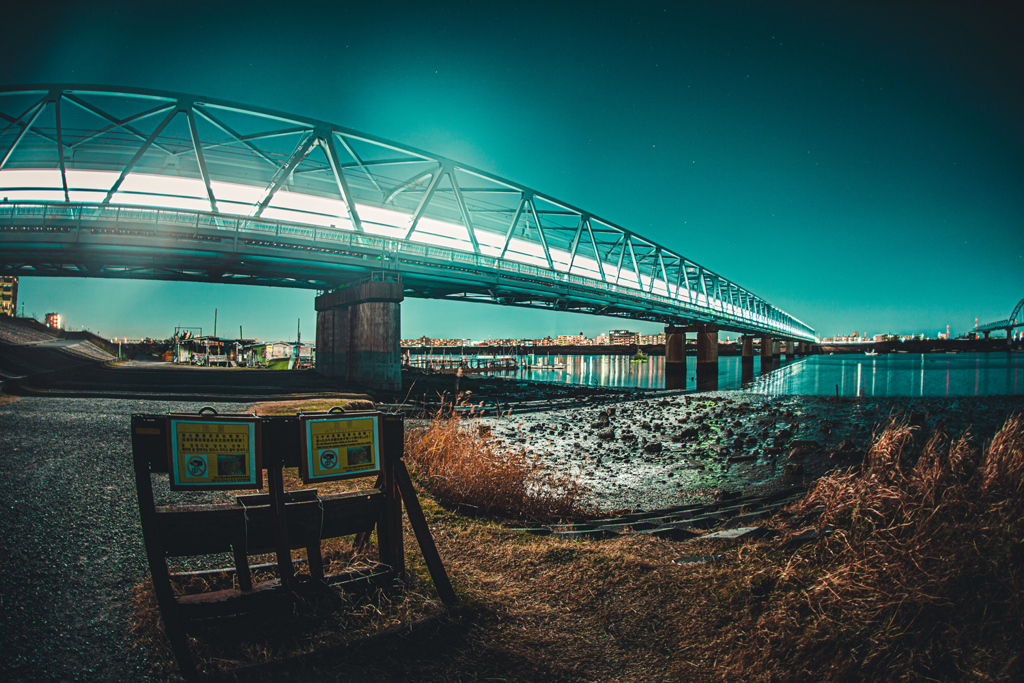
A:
131,409,458,680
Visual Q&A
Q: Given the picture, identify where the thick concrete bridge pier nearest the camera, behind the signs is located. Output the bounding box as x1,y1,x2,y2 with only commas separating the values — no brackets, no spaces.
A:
315,280,404,391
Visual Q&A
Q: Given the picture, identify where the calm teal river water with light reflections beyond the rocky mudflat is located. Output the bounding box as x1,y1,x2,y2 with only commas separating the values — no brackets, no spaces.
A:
485,352,1024,396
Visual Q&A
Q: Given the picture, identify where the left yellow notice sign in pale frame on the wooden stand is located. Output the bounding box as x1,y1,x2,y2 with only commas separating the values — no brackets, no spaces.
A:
167,415,263,490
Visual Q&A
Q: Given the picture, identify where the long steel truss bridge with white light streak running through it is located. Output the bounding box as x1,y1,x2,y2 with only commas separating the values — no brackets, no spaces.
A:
0,84,815,341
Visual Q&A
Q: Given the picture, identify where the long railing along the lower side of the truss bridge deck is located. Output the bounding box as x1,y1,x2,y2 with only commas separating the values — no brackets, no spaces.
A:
0,202,815,340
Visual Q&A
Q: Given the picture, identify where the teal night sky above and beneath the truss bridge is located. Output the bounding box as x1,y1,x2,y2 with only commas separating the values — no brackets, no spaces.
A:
0,2,1024,339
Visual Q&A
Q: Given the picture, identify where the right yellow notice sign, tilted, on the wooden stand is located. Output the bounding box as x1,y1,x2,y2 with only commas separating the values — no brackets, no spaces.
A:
299,413,381,483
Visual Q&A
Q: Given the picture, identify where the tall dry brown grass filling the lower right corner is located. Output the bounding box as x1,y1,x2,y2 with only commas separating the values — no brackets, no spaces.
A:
730,416,1024,681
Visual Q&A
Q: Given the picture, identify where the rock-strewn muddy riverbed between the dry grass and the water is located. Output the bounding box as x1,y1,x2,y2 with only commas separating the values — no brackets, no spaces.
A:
482,392,1024,510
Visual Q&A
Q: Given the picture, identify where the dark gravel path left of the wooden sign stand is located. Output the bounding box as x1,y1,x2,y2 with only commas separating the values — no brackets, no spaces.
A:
0,398,245,682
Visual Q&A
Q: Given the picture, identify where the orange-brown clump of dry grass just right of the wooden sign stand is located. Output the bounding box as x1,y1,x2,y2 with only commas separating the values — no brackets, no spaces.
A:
406,401,598,521
